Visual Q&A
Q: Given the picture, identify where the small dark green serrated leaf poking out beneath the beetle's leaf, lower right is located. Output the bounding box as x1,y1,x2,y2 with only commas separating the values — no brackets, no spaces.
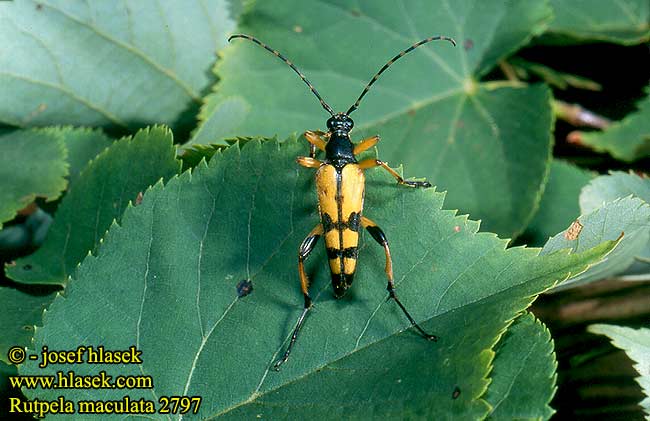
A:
485,314,557,420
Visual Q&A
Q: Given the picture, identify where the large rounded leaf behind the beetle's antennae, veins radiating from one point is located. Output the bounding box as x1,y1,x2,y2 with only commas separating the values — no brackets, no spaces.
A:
193,0,553,236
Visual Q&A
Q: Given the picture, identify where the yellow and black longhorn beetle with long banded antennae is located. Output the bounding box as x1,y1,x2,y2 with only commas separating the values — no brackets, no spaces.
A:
228,34,456,370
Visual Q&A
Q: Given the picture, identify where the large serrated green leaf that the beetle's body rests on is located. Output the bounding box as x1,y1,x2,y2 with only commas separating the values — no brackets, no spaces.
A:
20,140,614,419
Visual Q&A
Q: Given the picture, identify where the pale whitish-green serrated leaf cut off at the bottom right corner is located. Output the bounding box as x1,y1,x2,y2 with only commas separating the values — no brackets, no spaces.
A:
588,324,650,419
